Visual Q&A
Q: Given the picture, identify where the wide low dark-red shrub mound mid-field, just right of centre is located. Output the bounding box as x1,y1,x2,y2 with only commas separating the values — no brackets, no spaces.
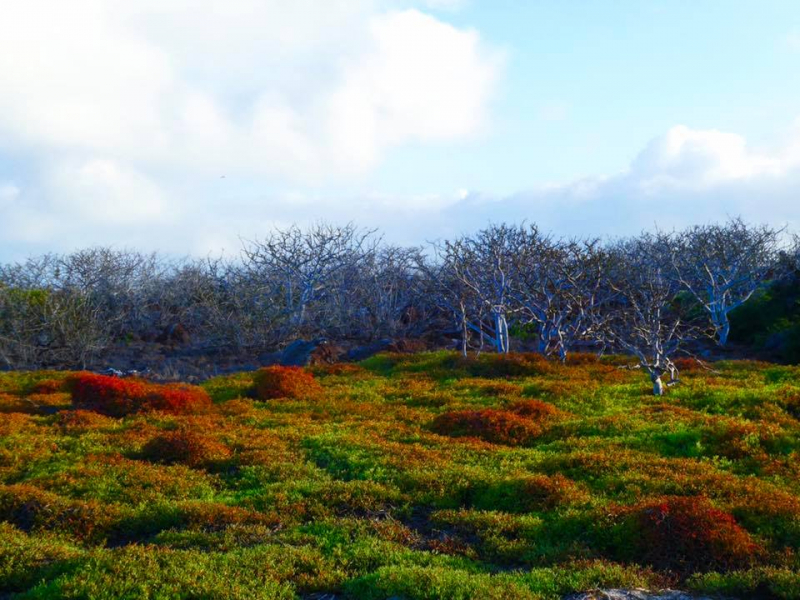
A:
432,408,542,446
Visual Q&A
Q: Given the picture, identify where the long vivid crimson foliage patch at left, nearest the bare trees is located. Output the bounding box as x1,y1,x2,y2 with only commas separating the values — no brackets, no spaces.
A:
68,373,211,417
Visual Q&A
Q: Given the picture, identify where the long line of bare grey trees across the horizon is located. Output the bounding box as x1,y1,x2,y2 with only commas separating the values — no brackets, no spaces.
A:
0,219,800,394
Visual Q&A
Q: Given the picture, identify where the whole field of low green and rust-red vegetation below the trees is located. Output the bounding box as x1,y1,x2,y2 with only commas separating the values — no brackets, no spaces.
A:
0,352,800,600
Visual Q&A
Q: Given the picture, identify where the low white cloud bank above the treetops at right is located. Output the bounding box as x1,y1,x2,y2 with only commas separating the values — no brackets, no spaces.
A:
440,125,800,236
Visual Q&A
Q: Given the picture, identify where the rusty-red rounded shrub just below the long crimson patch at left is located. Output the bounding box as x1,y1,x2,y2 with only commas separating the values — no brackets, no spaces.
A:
142,429,231,467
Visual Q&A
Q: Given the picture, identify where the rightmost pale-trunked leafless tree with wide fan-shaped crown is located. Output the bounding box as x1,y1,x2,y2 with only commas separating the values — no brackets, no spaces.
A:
670,218,780,346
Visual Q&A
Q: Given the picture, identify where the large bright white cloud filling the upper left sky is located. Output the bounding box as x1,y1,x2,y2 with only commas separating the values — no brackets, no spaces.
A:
0,0,501,183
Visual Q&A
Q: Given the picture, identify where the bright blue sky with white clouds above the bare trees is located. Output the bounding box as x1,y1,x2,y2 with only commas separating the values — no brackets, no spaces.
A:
0,0,800,261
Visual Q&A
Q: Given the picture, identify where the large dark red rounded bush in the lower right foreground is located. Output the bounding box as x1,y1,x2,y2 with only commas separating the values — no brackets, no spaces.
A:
630,496,762,575
